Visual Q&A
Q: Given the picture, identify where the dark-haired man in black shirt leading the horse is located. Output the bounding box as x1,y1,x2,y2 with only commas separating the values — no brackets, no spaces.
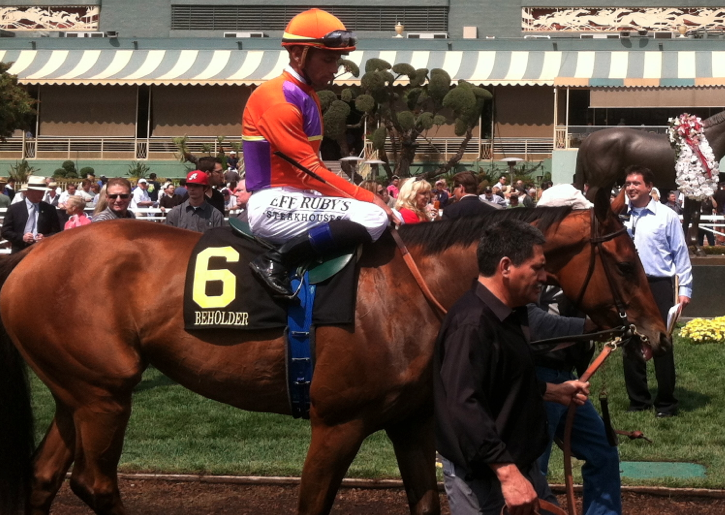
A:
434,220,589,515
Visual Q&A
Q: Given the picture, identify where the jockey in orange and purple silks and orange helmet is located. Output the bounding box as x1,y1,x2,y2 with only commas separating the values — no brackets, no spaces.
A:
242,9,393,298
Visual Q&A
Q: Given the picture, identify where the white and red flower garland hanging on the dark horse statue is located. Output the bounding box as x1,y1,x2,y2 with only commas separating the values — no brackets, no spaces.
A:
668,113,719,200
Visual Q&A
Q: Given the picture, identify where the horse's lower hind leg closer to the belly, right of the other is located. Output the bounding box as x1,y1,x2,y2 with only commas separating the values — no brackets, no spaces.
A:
70,393,131,515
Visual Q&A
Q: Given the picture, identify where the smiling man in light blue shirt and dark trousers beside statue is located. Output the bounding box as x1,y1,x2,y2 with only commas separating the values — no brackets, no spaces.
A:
623,165,692,418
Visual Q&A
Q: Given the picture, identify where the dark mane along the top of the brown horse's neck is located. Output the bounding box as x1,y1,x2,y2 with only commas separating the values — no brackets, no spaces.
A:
400,206,571,254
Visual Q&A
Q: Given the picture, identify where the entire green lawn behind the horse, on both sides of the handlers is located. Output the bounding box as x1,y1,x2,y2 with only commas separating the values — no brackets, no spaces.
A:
33,338,725,488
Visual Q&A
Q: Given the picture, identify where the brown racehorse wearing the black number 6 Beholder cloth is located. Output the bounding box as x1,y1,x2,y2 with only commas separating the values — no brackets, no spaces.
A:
0,190,670,515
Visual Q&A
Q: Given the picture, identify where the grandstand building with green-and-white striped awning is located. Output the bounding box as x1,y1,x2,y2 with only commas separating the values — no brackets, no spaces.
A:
0,0,725,182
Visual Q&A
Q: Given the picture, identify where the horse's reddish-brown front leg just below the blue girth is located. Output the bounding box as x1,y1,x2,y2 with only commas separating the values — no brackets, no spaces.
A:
299,418,367,515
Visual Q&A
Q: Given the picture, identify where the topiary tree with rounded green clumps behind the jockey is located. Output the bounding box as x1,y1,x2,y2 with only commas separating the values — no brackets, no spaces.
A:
320,59,492,177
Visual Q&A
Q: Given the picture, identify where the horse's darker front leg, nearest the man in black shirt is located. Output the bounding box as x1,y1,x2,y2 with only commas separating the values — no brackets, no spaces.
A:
386,414,440,515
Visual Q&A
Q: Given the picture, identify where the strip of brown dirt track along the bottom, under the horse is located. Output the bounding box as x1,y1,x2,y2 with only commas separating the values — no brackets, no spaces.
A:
46,479,725,515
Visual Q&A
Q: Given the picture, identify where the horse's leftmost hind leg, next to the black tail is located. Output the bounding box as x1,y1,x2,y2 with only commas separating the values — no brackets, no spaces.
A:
27,406,75,515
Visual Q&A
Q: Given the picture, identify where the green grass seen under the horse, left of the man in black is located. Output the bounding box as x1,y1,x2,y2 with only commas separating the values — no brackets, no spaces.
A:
33,369,398,478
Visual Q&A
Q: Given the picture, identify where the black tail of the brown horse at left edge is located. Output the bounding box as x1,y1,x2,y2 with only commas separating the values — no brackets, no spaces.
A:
0,251,35,513
